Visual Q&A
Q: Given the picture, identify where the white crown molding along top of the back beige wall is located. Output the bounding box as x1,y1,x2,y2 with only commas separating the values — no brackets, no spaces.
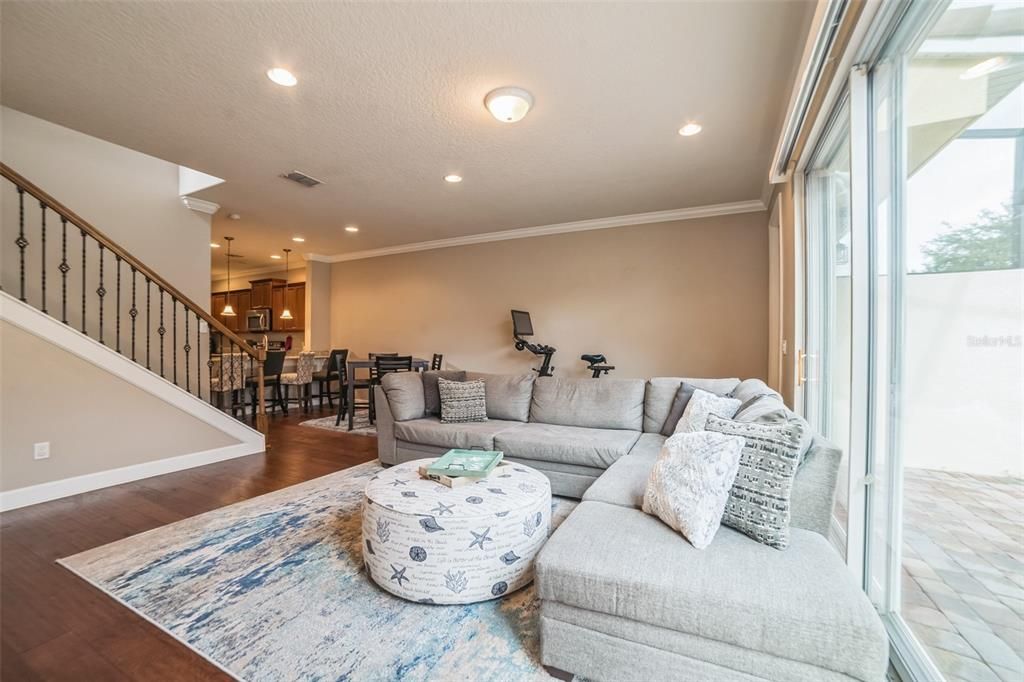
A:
315,199,765,263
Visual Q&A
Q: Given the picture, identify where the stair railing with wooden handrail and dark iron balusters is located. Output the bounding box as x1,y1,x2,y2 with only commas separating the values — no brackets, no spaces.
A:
0,163,267,435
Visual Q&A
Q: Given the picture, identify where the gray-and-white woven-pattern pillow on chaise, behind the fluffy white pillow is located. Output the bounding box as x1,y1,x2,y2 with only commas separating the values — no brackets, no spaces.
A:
708,415,804,549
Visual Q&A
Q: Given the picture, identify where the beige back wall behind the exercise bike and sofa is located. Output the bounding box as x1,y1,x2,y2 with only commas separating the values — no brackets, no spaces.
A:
331,212,768,378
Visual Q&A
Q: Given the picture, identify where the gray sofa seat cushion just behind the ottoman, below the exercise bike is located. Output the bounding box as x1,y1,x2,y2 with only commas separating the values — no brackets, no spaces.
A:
495,419,640,469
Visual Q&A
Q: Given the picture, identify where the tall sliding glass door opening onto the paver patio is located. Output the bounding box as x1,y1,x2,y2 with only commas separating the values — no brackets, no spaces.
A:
804,0,1024,681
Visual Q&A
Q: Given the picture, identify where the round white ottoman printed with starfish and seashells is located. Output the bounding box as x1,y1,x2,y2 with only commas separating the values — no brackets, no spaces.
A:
362,458,551,604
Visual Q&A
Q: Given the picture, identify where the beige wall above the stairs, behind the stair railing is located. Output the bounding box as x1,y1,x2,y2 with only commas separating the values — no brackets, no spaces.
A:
0,108,210,308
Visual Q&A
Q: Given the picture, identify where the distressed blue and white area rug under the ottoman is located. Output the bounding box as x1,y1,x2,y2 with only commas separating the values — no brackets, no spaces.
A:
59,463,575,682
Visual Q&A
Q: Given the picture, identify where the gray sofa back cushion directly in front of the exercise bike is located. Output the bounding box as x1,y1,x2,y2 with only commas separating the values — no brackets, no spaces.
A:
529,377,644,431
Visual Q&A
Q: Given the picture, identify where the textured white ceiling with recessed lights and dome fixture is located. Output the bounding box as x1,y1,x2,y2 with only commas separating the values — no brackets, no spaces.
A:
0,0,814,270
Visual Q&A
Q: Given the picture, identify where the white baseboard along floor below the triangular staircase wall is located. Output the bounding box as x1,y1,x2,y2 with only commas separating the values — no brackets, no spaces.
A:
0,442,263,512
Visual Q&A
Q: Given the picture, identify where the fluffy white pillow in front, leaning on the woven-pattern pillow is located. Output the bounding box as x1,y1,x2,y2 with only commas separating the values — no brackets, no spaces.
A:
643,431,745,549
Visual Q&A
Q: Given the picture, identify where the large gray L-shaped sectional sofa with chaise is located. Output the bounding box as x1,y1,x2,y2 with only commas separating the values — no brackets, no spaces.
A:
375,373,888,681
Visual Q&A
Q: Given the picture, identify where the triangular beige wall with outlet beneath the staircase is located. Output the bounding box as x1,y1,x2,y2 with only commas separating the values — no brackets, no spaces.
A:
0,322,238,491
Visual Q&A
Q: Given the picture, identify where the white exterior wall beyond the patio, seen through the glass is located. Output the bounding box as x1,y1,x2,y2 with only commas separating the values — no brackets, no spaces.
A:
900,269,1024,476
